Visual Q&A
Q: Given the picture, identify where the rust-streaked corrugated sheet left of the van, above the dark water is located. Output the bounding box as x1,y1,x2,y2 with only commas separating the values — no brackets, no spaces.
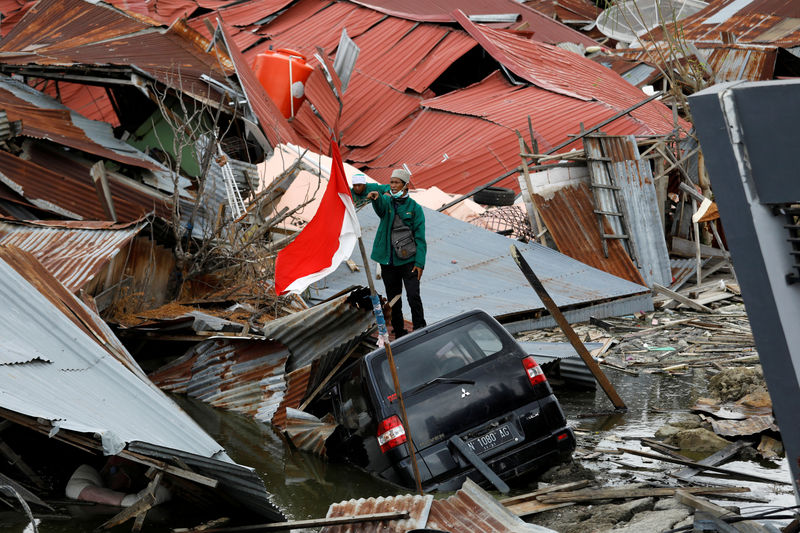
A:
149,339,289,422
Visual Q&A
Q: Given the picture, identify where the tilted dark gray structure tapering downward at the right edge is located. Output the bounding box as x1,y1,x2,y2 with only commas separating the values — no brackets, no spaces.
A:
689,81,800,501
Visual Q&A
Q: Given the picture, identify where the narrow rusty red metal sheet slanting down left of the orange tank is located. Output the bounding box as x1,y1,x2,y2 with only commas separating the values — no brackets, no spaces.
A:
220,20,299,146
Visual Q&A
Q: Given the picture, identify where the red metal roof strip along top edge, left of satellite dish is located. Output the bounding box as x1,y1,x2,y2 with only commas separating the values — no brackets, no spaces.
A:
346,0,597,46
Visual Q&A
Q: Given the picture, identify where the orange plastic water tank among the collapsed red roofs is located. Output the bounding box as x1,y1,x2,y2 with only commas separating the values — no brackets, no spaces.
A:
253,48,314,118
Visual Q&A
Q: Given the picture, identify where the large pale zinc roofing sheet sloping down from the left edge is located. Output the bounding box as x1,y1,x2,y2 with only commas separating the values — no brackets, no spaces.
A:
0,248,226,458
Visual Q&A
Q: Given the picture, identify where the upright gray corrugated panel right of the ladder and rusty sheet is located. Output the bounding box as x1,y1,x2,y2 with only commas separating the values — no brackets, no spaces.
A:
613,159,672,286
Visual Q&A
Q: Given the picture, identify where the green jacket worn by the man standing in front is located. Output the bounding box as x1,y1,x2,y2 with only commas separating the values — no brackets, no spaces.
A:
371,194,428,268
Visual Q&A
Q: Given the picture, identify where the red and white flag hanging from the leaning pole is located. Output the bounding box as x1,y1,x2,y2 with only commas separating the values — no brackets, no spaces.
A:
275,138,361,294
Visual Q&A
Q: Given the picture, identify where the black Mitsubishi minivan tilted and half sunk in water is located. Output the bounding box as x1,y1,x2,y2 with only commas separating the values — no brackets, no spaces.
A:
308,311,575,491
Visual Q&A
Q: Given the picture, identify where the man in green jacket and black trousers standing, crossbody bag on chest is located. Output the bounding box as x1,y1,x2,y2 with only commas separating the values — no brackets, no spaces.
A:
367,169,427,338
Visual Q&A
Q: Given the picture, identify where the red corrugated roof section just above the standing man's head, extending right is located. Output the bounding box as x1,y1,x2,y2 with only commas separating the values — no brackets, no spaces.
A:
354,71,672,193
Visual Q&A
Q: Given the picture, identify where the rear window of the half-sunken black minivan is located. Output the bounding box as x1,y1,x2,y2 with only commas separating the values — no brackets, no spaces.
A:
379,321,503,396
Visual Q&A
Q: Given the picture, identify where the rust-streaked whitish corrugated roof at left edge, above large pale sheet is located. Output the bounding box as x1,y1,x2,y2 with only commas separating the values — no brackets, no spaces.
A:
0,216,146,292
